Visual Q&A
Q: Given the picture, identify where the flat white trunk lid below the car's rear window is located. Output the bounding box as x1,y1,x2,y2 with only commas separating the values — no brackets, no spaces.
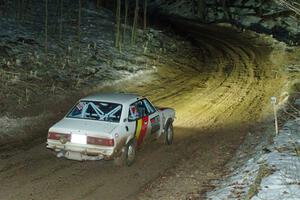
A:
49,118,119,137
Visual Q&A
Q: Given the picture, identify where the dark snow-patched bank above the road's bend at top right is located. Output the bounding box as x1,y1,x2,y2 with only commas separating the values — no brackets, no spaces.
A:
152,0,300,45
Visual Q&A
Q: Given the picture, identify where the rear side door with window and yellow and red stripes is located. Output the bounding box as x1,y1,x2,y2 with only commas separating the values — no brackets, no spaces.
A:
129,100,149,146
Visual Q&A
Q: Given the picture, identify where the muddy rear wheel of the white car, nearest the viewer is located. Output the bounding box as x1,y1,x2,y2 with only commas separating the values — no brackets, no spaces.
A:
114,139,136,166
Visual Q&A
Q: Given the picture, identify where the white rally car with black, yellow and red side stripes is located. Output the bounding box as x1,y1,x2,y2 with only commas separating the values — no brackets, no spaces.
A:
47,93,175,165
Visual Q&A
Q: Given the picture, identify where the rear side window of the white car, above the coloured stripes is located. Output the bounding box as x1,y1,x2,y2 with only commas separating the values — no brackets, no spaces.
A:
128,100,149,121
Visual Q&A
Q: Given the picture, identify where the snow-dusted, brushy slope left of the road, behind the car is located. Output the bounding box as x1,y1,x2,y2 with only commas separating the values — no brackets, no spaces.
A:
0,1,178,147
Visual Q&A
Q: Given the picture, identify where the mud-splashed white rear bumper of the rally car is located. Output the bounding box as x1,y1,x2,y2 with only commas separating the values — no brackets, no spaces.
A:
47,140,117,161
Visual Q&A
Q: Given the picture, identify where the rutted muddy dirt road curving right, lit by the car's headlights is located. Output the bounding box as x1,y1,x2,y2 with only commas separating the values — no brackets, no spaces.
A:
0,22,285,199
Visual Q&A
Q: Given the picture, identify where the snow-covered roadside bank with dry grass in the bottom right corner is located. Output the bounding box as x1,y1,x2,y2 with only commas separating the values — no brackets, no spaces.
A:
207,108,300,200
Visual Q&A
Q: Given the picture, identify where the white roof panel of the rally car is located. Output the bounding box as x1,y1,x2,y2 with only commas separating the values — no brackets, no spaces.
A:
81,93,141,104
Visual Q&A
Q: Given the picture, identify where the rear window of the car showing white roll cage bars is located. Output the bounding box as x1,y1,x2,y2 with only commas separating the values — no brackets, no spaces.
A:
67,101,122,122
